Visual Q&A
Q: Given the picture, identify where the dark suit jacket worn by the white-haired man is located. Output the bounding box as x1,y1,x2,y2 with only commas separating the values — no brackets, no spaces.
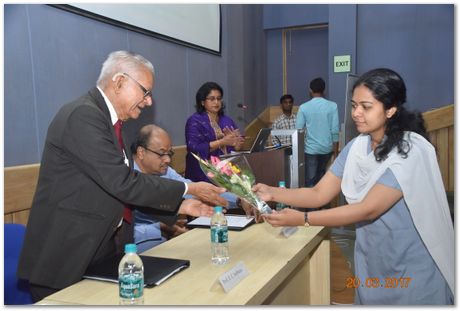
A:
18,88,185,289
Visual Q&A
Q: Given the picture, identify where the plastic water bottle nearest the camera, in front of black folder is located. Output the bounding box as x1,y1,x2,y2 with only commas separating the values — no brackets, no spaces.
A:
118,244,144,305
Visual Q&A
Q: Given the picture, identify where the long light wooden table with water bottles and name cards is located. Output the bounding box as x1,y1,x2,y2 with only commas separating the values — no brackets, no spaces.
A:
37,223,330,305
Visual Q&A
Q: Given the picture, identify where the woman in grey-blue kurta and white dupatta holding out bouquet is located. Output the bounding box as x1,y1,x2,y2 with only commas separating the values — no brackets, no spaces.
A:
253,69,454,305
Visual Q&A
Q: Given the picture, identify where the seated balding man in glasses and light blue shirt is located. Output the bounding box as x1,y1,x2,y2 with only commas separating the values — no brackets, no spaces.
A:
131,124,239,253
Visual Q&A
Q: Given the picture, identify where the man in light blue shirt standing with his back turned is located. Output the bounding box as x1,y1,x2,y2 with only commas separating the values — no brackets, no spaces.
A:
296,78,339,187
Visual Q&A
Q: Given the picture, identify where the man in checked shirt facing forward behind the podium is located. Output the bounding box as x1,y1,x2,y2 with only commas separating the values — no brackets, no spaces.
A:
272,94,296,146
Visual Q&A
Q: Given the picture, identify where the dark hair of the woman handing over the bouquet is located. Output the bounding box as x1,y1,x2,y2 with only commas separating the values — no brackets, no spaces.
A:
353,68,429,162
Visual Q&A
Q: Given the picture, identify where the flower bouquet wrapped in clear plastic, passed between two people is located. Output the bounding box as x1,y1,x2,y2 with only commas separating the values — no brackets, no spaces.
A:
192,153,272,214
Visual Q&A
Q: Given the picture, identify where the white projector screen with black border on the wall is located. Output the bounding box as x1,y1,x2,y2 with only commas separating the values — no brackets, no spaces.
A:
52,3,221,55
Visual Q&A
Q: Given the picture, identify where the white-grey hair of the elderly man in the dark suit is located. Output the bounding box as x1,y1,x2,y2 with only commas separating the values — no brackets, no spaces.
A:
97,51,155,88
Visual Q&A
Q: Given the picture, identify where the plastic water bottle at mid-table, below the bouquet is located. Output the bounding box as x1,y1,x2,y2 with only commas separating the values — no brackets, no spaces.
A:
211,206,230,265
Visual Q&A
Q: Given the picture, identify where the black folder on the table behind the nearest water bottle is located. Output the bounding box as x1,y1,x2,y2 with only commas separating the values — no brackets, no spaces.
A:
83,254,190,287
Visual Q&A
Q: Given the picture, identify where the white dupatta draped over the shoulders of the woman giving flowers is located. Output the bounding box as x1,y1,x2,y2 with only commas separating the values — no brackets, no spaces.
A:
342,132,455,295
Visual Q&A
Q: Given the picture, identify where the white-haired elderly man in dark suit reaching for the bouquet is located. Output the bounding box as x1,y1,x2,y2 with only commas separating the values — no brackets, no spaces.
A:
18,51,227,301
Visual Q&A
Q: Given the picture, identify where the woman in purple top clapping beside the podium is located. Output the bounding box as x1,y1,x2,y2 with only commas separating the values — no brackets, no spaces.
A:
185,82,244,182
